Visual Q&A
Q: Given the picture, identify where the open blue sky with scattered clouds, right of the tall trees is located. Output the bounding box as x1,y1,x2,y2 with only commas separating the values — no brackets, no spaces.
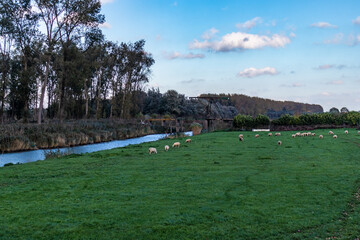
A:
101,0,360,111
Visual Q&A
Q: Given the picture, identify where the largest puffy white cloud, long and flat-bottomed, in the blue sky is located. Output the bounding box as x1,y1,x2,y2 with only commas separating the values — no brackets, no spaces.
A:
189,32,291,52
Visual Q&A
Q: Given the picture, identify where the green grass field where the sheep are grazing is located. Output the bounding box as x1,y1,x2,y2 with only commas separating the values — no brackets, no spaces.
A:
0,129,360,239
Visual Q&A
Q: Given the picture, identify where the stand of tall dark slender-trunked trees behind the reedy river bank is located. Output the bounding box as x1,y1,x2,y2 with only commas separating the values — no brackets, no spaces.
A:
0,0,155,123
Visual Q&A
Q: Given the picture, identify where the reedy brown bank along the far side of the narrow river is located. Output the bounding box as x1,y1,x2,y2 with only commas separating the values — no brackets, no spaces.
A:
0,120,164,153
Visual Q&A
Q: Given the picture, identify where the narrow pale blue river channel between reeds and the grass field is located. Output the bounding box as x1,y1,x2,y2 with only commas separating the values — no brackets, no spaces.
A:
0,132,192,167
